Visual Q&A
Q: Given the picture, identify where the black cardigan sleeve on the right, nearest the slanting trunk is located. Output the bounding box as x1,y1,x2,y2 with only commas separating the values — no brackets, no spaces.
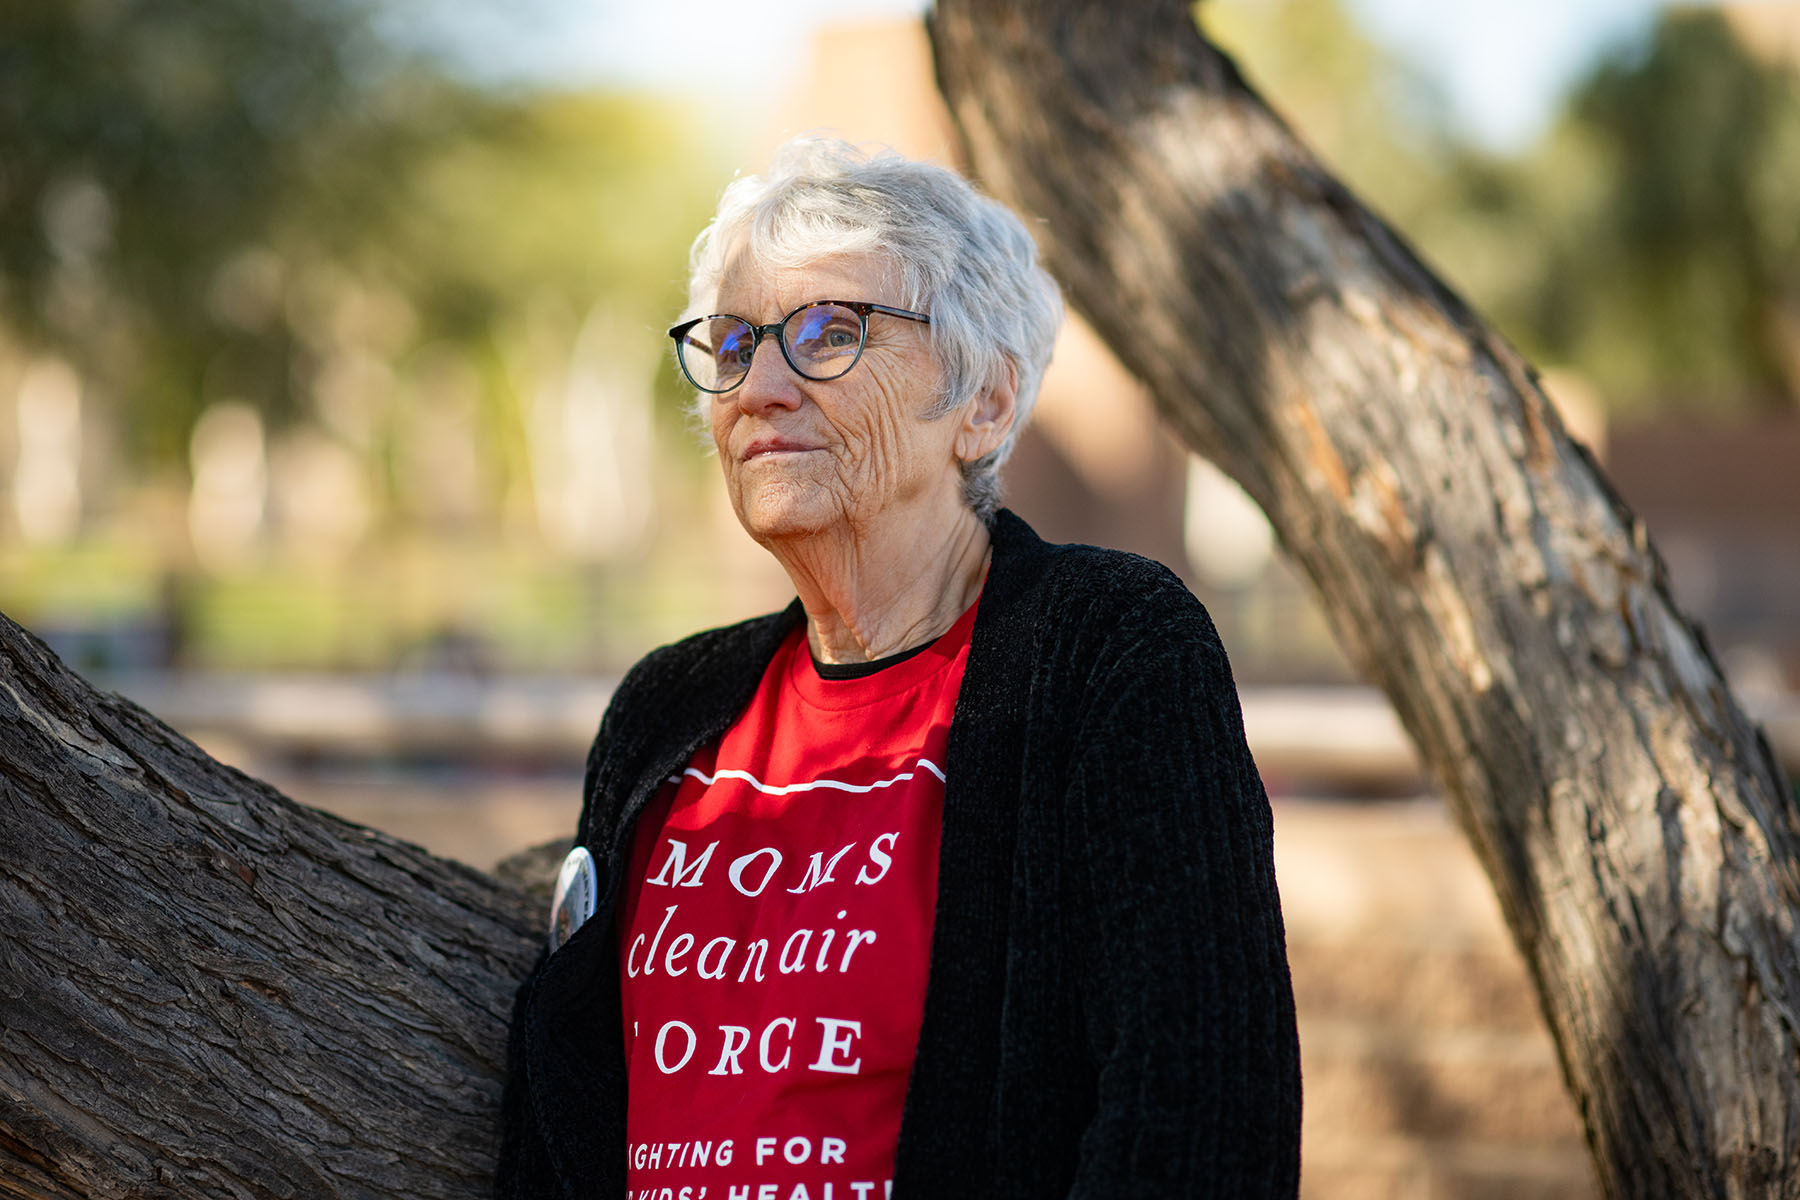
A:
1066,592,1300,1198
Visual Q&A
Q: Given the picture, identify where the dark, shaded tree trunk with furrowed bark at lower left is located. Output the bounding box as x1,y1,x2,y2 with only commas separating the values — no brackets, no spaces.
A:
0,617,544,1198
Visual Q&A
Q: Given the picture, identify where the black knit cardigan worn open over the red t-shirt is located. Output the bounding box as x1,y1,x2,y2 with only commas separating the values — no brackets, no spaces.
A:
495,511,1300,1200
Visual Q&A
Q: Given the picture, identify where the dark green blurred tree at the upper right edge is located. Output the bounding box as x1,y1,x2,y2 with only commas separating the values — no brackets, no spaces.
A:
1525,11,1800,407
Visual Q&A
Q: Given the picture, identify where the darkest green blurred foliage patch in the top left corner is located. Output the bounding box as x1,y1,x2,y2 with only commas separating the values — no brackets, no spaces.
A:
0,0,369,457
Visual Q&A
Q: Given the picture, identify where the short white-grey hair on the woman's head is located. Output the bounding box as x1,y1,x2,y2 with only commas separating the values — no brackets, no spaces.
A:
686,137,1062,518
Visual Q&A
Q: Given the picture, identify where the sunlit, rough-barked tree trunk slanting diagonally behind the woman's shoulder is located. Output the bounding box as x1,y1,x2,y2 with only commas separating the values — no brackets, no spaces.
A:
931,0,1800,1200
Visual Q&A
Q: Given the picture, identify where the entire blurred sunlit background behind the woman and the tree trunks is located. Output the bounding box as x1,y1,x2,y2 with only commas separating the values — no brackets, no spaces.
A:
0,0,1800,1196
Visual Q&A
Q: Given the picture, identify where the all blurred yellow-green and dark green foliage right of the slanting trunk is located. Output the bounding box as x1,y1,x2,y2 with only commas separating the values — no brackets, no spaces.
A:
1201,0,1800,414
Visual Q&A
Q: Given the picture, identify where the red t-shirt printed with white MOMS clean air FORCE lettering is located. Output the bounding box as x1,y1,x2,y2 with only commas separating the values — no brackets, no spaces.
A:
619,604,976,1200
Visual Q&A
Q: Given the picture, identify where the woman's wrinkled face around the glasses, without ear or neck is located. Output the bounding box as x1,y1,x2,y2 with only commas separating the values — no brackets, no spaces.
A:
709,255,961,542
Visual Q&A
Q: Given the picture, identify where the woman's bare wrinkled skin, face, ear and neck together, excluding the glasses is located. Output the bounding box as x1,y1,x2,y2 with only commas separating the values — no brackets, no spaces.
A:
709,255,1013,662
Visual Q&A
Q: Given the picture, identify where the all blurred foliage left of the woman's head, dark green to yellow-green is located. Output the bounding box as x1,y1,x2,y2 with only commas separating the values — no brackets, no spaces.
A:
0,0,709,468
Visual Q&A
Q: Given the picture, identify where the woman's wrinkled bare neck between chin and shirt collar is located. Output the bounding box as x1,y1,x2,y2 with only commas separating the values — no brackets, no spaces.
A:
769,504,988,662
